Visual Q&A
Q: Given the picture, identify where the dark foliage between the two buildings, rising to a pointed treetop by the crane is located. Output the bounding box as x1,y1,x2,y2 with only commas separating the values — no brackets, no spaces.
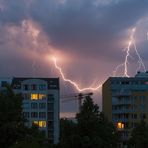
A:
59,97,119,148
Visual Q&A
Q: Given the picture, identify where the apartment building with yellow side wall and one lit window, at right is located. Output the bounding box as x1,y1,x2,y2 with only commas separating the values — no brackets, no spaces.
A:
102,72,148,146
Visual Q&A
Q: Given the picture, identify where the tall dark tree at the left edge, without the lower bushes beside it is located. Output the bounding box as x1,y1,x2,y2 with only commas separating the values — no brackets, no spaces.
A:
0,87,23,148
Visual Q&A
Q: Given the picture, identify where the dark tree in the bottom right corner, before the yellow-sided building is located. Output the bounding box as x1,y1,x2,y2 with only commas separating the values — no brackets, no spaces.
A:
129,120,148,148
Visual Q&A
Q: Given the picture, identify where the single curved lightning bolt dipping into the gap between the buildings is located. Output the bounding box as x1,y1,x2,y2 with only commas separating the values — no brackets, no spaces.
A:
52,57,102,92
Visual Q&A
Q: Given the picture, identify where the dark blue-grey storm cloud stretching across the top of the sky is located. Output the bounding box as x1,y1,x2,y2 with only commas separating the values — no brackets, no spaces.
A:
0,0,148,59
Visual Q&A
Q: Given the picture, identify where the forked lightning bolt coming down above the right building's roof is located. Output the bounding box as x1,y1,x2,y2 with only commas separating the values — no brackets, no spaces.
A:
113,27,146,77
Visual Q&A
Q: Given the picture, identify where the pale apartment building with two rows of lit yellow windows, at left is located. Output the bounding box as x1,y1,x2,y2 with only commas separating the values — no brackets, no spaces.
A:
0,78,59,144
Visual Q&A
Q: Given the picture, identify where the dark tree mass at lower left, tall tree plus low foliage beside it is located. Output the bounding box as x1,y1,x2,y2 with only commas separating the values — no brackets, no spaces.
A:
0,86,45,148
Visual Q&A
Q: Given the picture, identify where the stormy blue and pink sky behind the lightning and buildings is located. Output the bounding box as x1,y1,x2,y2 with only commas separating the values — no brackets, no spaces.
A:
0,0,148,115
